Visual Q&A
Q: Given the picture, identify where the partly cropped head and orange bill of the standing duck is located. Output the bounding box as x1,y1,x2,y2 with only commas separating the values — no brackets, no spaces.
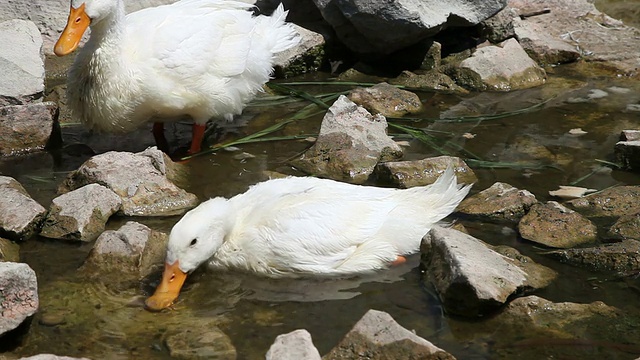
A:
53,0,118,56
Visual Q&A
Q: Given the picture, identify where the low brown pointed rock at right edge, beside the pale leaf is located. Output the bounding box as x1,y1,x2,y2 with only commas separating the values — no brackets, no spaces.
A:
565,186,640,218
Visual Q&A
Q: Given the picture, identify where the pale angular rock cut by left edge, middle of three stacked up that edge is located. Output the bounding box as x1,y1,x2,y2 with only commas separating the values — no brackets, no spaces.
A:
0,176,47,241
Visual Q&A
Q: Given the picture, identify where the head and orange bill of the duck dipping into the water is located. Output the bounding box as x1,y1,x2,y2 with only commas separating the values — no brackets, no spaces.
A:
145,198,229,311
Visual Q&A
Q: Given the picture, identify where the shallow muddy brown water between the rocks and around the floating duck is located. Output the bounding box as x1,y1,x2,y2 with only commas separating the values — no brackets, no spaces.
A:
0,62,640,359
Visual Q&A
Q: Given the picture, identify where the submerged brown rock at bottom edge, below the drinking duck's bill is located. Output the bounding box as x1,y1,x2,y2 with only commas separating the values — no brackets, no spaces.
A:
165,325,237,360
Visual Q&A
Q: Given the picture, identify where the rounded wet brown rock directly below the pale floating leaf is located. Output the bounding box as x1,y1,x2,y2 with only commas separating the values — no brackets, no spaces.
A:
518,201,598,249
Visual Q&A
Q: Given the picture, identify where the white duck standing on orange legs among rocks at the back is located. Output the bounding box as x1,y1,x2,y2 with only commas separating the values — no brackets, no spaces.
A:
54,0,299,153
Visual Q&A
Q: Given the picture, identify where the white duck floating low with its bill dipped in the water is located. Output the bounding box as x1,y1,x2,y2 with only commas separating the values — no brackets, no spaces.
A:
146,168,470,310
